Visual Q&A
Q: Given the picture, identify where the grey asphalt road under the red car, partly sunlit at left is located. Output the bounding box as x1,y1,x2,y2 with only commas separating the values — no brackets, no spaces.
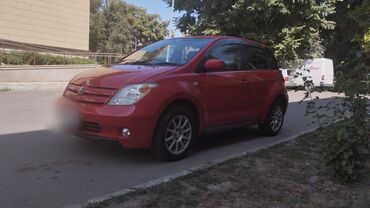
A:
0,91,336,208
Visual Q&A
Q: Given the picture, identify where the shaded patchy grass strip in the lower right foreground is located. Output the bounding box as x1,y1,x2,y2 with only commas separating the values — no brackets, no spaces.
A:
89,129,370,208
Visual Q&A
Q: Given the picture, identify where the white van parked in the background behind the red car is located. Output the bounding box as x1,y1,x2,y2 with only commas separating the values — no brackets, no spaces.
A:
280,58,334,90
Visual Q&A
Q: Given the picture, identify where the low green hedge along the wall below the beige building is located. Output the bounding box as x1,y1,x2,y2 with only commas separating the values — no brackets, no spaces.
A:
0,52,96,65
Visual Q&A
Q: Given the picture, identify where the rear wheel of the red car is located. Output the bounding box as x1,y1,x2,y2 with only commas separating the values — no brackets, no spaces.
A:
259,100,284,136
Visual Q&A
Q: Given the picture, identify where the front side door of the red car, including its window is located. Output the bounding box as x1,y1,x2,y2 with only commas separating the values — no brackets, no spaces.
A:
201,41,244,127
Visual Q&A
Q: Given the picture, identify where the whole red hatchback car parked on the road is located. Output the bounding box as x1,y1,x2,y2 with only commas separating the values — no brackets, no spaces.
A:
62,37,288,161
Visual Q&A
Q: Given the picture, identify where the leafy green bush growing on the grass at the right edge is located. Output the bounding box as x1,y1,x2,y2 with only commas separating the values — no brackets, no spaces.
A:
305,56,370,181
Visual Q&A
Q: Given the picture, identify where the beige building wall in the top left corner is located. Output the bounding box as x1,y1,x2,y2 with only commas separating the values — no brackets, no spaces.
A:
0,0,90,52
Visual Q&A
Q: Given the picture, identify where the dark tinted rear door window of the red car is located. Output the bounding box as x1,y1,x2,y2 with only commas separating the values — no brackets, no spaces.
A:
242,45,269,69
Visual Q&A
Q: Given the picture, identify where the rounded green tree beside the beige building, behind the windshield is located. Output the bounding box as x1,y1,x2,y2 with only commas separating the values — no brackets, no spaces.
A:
90,0,168,54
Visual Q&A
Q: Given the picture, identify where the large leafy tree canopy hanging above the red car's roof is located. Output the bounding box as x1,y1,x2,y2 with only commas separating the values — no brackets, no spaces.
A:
164,0,335,66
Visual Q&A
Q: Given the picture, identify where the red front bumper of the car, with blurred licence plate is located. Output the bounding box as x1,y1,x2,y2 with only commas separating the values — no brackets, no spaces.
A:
61,98,158,148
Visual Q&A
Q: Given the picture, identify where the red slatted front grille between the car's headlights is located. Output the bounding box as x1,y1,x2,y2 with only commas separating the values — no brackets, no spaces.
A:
64,84,115,104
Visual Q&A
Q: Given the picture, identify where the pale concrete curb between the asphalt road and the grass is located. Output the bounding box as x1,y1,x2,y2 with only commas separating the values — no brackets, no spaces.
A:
64,127,318,208
